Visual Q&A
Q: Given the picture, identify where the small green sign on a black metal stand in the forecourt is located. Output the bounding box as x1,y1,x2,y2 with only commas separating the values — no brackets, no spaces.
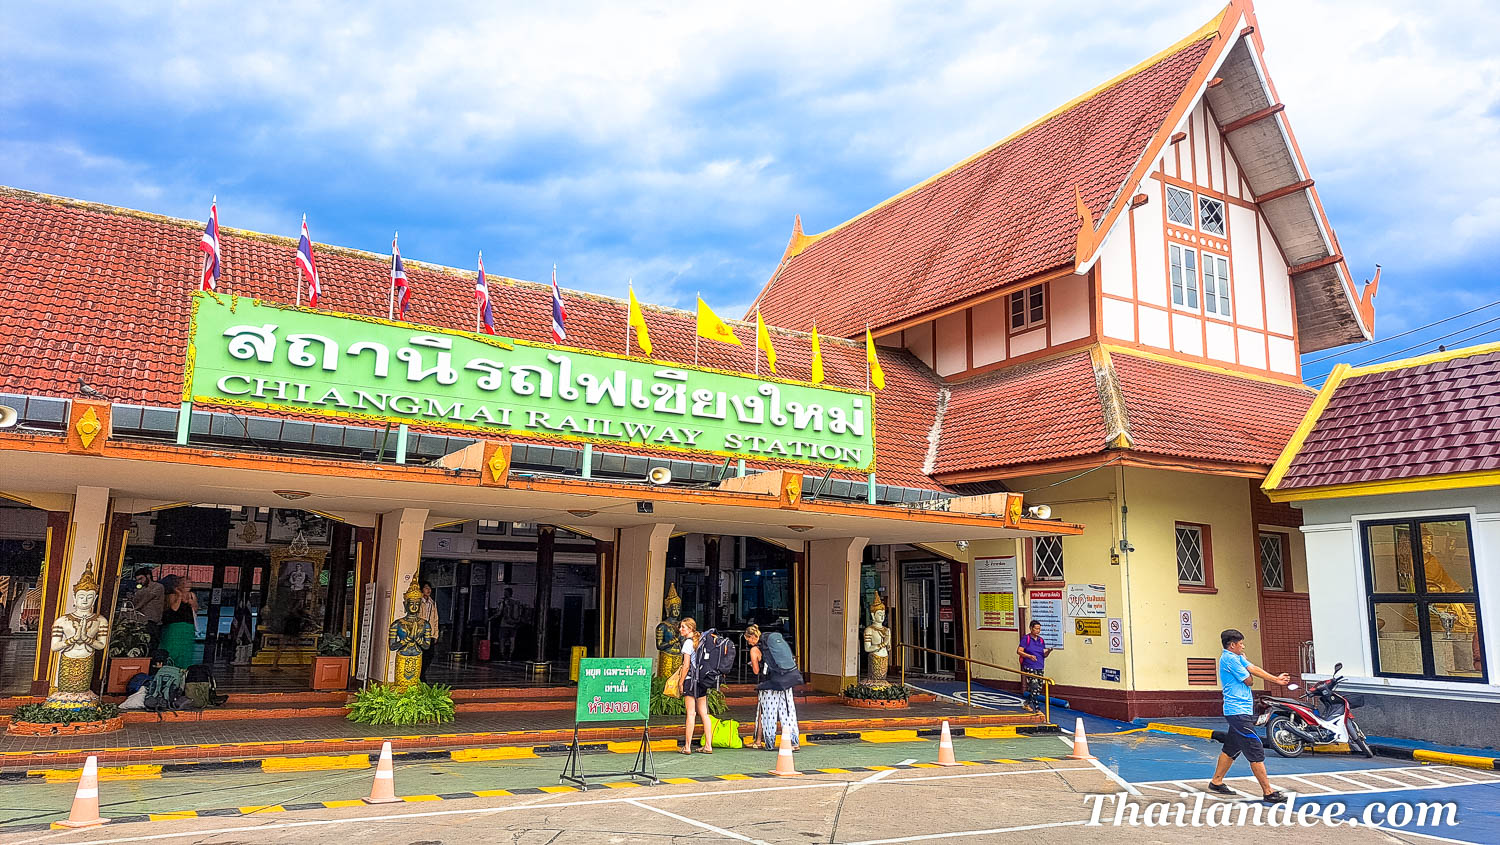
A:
558,657,659,789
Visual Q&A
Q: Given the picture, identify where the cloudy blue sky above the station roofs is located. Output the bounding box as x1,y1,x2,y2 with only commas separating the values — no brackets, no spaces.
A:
0,0,1500,381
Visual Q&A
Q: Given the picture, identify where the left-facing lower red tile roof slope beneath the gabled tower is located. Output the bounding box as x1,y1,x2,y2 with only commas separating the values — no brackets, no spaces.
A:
933,350,1106,474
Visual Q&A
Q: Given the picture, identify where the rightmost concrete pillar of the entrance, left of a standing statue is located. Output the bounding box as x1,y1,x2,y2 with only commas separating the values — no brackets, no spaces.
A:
807,537,870,692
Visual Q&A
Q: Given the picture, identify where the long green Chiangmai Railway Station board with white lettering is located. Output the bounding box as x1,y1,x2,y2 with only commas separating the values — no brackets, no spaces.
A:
183,291,875,471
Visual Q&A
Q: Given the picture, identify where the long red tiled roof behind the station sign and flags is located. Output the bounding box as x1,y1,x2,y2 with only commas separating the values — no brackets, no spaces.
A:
0,189,939,489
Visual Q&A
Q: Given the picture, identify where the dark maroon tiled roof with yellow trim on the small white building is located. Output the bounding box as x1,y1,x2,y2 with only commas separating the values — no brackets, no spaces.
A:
1277,344,1500,489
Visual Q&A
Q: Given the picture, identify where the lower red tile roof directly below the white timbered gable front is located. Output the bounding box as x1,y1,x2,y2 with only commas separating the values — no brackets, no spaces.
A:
1110,350,1314,468
